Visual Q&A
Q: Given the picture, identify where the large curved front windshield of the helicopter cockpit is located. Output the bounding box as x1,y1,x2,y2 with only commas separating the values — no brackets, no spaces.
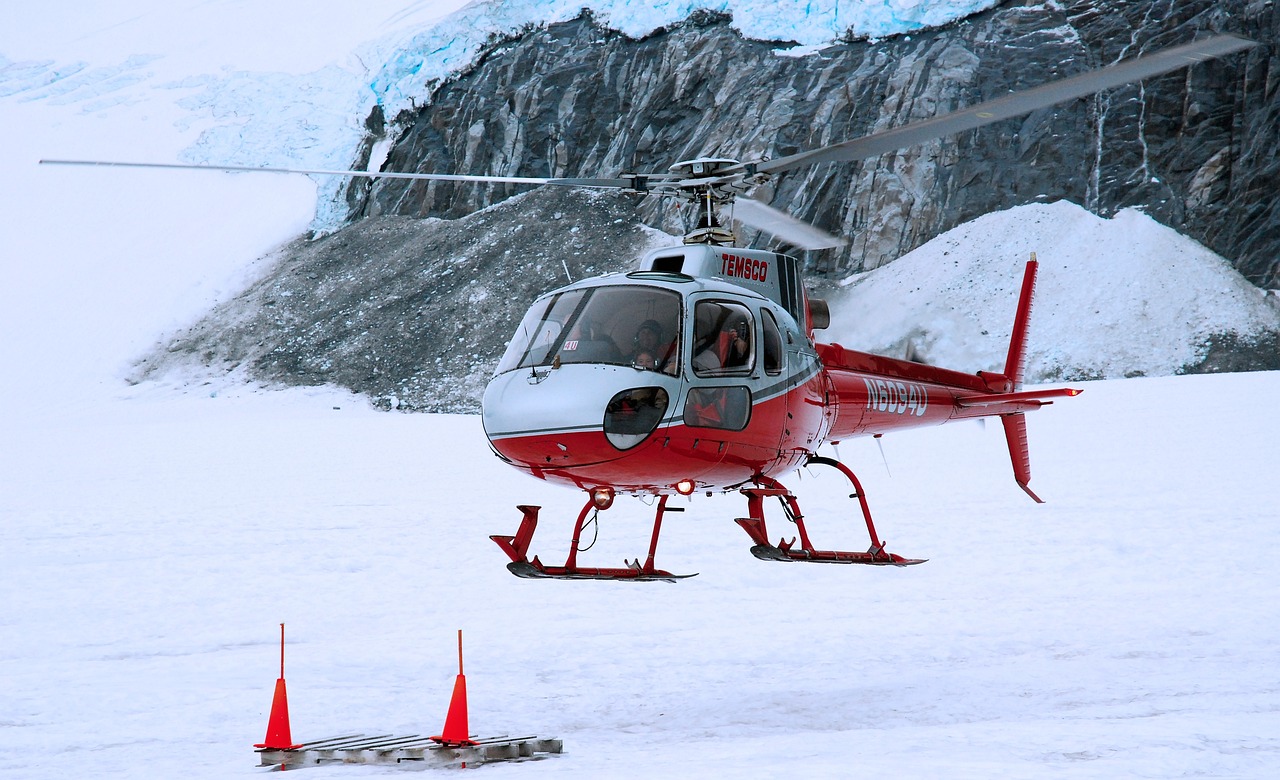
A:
498,284,680,375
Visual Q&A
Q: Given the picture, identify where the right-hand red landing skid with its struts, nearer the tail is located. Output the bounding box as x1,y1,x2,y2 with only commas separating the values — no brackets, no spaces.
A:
735,455,928,566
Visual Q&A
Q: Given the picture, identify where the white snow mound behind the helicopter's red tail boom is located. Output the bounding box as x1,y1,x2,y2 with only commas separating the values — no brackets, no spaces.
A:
827,201,1280,382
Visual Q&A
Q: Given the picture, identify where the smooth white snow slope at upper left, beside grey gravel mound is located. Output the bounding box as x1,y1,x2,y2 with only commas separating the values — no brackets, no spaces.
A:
0,0,455,415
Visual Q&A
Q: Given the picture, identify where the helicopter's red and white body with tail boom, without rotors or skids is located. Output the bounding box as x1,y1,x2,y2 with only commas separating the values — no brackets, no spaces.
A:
483,246,1038,494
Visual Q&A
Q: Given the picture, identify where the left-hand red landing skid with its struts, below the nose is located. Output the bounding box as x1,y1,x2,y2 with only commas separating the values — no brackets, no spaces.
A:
489,496,695,583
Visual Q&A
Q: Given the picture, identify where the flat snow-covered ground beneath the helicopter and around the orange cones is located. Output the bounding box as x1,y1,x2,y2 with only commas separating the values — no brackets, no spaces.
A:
0,373,1280,779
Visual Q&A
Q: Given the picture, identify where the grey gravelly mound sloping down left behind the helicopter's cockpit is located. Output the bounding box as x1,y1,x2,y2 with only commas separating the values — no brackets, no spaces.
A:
129,187,676,412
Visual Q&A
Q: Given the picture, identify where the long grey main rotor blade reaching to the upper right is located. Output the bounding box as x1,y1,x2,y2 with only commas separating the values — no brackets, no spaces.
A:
747,35,1258,175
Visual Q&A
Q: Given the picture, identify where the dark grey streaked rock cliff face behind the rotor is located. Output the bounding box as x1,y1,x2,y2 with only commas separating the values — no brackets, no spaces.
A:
347,0,1280,287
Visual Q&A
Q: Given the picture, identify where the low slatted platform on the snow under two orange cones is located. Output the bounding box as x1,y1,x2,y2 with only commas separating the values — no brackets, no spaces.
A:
257,734,563,768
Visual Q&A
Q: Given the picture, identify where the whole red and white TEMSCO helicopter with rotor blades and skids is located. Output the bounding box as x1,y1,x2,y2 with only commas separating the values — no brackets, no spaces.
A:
42,36,1256,581
